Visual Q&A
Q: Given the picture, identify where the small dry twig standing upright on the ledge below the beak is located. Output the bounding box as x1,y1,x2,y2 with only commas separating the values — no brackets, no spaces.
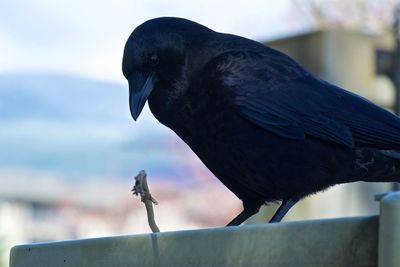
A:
131,170,160,233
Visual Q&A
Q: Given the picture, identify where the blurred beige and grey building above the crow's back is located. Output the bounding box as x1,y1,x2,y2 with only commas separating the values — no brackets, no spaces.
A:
266,29,394,105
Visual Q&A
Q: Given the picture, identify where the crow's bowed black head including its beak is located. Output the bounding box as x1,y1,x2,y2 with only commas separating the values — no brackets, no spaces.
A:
122,17,212,120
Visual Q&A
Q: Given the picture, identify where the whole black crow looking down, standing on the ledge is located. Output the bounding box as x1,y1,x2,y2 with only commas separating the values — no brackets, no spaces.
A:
122,17,400,226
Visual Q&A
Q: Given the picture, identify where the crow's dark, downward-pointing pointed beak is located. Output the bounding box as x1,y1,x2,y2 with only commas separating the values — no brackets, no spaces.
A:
128,73,155,121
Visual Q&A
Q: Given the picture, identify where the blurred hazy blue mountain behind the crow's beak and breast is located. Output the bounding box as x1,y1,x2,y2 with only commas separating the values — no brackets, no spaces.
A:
0,74,209,183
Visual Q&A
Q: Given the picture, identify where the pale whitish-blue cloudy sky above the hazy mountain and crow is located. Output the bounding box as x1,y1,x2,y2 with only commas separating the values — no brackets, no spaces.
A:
0,0,310,83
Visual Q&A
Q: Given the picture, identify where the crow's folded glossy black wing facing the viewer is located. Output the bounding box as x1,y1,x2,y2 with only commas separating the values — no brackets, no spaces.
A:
212,49,400,149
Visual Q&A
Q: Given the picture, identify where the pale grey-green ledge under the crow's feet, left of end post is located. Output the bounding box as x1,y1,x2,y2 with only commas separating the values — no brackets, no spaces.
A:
10,217,378,267
